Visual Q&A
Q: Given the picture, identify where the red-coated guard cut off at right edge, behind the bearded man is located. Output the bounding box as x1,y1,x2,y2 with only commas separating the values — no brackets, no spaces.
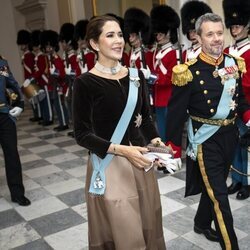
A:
223,0,250,200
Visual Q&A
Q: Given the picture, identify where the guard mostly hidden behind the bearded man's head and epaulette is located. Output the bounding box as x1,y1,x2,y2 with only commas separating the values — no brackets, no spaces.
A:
181,0,213,62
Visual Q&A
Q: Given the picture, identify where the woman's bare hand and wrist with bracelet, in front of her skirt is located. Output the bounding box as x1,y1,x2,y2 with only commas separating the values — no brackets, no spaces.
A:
108,144,151,168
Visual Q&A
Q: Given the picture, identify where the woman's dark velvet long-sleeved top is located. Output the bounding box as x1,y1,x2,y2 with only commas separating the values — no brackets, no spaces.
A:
73,72,158,158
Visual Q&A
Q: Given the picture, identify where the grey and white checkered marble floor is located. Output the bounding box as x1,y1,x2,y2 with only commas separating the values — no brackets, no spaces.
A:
0,106,250,250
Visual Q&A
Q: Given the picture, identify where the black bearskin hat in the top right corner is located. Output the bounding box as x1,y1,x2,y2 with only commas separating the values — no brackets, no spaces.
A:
222,0,250,28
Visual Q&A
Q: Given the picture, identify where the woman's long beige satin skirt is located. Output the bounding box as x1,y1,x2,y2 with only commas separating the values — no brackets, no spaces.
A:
85,156,166,250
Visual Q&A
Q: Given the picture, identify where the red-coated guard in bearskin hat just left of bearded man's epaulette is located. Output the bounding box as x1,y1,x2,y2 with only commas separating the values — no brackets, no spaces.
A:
150,5,180,145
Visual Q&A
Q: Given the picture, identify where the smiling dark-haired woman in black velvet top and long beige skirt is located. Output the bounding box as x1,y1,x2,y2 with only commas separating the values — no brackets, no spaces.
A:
73,16,165,250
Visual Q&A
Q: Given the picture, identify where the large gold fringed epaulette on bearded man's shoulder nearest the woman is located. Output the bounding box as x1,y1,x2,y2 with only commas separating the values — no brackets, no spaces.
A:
172,59,197,86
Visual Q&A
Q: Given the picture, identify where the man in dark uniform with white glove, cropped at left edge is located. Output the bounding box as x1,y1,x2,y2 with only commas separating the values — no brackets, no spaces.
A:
0,56,30,206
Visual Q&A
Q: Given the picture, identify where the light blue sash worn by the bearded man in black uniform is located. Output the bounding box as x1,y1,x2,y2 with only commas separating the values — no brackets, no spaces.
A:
186,57,236,160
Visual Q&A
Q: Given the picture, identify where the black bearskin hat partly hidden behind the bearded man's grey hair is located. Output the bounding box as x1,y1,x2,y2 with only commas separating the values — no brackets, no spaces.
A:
181,0,213,35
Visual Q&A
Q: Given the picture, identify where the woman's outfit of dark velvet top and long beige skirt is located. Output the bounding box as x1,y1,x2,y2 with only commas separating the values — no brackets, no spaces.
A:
73,72,165,250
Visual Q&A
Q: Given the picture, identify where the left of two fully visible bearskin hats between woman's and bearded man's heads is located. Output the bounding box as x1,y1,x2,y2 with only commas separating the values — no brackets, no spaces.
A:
124,7,151,44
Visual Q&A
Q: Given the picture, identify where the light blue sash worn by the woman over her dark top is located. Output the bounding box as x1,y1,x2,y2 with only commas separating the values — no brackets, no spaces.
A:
89,68,140,195
